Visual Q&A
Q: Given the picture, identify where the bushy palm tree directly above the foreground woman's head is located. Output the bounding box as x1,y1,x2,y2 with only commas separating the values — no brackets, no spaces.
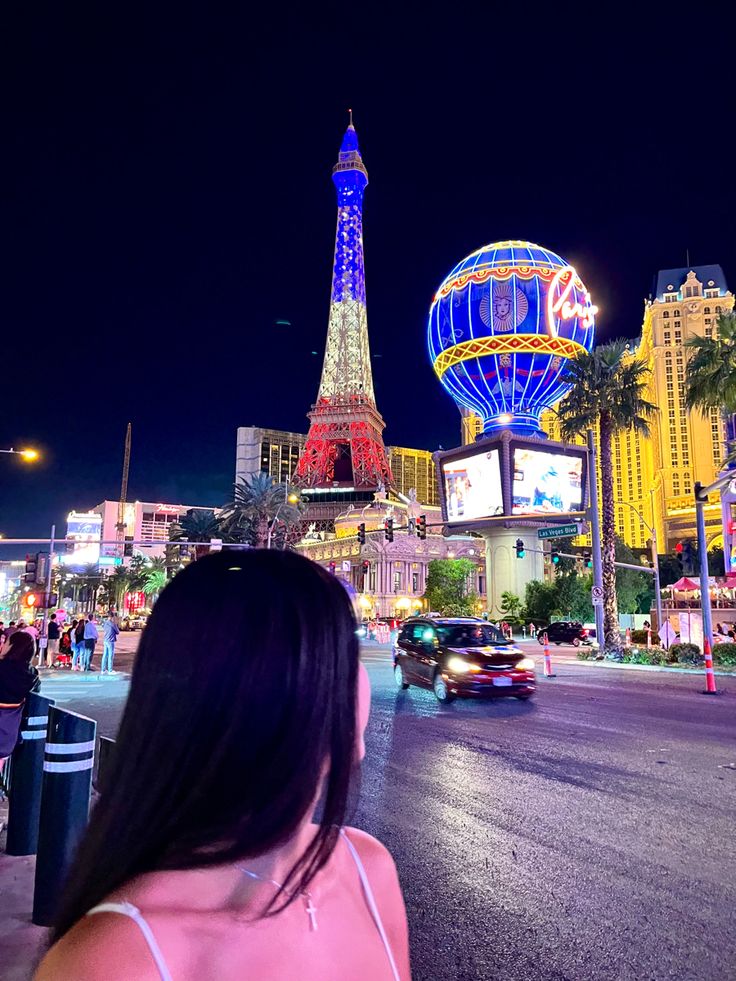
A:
220,472,301,548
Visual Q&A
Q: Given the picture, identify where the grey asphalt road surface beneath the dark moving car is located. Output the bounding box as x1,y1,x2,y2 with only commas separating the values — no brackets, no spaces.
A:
38,647,736,981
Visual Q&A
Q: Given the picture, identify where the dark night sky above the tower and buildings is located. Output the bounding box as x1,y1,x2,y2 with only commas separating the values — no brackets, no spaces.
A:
0,3,736,554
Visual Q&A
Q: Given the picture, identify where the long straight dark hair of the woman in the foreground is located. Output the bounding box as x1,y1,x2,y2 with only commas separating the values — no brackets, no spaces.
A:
52,550,358,940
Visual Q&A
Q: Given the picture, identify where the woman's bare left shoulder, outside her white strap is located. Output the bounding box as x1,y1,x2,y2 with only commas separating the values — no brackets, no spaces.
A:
33,913,160,981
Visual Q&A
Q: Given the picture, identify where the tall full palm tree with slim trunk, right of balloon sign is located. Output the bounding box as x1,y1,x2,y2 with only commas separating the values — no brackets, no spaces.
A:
557,340,657,654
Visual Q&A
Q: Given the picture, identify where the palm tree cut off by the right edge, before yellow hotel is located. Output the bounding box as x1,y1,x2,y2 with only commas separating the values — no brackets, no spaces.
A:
685,311,736,463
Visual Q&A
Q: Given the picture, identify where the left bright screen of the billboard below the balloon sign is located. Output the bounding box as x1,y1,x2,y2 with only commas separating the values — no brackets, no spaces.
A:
442,448,503,523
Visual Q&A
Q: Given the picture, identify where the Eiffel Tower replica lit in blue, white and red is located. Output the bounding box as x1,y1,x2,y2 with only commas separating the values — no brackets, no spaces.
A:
294,110,393,531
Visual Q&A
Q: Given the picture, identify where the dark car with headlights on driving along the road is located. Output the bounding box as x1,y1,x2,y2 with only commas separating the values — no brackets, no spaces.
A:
393,617,536,703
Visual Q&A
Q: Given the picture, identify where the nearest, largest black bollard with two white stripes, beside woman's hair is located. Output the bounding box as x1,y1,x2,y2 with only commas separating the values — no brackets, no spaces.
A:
32,708,97,926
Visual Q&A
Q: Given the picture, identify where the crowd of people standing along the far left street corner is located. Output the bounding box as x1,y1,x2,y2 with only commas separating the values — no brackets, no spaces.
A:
0,610,120,674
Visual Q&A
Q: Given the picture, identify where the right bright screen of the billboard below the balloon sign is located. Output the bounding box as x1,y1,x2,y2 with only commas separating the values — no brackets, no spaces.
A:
511,445,585,514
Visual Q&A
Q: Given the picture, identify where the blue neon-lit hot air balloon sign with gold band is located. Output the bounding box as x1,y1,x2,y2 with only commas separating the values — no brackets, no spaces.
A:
427,241,597,436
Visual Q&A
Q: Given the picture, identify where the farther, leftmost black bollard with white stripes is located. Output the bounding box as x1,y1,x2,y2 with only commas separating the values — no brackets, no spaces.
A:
5,692,54,855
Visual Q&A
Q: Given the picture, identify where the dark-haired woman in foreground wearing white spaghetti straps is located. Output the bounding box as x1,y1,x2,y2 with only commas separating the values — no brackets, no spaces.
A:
36,550,410,981
